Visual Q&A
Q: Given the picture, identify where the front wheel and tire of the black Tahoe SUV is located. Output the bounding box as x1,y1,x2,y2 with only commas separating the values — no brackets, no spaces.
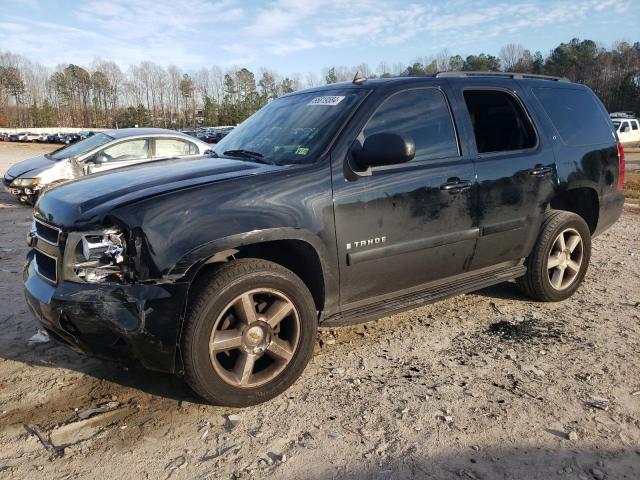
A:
181,259,318,407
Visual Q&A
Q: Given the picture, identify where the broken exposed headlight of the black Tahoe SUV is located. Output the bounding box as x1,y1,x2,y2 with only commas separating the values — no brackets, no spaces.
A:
68,228,127,283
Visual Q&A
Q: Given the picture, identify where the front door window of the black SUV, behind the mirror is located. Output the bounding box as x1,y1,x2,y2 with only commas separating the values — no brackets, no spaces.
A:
363,88,458,161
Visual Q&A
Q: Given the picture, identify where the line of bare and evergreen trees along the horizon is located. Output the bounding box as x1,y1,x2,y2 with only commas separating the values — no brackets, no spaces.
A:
0,39,640,128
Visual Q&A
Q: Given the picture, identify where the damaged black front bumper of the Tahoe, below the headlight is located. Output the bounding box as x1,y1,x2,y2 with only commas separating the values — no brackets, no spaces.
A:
23,253,188,373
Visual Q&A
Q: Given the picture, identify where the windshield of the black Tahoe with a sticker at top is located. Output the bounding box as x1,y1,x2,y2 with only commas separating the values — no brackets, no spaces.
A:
215,89,368,165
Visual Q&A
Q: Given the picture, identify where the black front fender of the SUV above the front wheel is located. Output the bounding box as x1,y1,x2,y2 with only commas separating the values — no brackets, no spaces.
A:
112,160,338,312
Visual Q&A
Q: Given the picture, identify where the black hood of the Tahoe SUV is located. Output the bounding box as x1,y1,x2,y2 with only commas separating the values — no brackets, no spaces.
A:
34,156,276,228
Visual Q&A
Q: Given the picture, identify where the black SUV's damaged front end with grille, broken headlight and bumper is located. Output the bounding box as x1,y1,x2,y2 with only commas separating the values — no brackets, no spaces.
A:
23,219,188,372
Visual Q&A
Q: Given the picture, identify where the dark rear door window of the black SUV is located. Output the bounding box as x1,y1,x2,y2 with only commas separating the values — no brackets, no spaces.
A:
464,90,536,153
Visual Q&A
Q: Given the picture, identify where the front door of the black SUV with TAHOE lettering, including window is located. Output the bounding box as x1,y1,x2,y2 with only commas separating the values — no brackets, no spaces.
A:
333,87,478,309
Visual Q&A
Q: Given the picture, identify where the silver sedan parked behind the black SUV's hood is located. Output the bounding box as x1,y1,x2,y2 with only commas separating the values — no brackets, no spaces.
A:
3,128,211,205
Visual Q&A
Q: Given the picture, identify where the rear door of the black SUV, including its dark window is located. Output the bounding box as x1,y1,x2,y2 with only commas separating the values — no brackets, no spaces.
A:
452,79,556,269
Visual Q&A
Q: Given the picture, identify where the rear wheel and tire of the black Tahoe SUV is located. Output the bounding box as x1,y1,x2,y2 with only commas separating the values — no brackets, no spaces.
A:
516,210,591,302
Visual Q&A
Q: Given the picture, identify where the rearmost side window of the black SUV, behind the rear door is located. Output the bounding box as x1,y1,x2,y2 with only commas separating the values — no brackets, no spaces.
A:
533,88,613,146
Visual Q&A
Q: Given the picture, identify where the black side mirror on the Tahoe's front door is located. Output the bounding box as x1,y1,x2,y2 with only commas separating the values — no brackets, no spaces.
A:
353,132,416,168
